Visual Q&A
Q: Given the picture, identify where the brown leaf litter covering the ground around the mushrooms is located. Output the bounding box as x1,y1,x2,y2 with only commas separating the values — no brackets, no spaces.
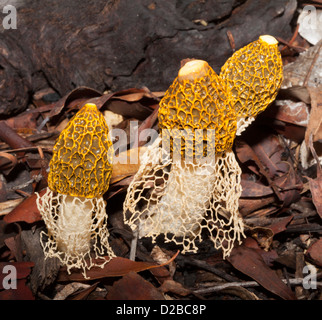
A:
0,1,322,302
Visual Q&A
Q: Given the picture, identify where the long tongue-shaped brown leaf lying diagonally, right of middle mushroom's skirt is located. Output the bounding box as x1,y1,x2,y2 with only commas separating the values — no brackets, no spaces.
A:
227,245,295,300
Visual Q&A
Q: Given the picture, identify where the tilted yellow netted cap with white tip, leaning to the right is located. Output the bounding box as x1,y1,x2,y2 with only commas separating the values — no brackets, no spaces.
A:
220,35,283,117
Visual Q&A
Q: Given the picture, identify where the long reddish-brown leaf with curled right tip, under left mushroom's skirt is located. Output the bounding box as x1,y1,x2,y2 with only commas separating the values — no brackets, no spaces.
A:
58,251,179,281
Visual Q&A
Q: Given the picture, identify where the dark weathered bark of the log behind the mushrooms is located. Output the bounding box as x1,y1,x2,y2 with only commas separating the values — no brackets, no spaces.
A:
0,0,296,116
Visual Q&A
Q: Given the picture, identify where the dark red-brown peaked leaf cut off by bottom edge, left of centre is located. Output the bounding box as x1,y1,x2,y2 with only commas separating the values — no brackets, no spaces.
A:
106,271,164,300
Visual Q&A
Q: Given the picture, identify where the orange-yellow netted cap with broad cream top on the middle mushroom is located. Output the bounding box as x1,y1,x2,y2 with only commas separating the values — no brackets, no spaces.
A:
158,60,236,154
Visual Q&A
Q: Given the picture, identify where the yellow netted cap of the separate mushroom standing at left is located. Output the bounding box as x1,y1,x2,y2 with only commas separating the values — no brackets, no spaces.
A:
48,103,113,198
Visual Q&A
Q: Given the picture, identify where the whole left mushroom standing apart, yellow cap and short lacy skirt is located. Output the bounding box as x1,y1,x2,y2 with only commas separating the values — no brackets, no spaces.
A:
37,103,114,276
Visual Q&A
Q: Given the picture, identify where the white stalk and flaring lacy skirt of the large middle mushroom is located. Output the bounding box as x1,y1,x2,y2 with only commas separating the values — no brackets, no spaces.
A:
124,138,244,257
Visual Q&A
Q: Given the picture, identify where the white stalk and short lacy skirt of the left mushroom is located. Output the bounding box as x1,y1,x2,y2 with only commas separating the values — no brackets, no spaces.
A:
37,188,114,275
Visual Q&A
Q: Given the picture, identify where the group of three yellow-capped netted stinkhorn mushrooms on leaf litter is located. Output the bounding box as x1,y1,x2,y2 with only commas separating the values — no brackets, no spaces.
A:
37,36,282,273
